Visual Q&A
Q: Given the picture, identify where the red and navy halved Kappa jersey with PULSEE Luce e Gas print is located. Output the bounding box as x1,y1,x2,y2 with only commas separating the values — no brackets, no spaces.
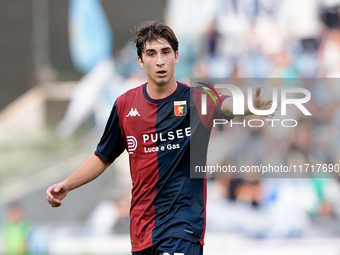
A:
95,83,230,252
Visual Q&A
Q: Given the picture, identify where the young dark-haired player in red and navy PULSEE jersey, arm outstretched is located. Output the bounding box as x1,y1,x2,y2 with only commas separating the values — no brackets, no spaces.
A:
46,22,271,255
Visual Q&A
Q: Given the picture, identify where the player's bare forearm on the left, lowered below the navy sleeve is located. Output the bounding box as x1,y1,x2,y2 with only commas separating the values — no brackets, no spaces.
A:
63,154,110,191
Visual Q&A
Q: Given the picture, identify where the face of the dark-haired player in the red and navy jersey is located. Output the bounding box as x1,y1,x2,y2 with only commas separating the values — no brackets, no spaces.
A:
138,39,178,86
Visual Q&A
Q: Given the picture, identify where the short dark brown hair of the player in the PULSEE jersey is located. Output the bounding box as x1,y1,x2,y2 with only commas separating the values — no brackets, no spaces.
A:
134,21,178,58
